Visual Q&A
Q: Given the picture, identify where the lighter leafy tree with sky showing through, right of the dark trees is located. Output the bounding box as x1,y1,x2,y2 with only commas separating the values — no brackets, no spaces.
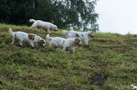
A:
52,0,99,31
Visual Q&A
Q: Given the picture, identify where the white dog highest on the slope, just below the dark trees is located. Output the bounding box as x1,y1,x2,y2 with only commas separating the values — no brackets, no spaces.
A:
29,19,58,33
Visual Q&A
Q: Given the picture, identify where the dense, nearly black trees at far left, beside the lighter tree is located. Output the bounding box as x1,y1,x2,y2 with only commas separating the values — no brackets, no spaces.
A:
0,0,54,25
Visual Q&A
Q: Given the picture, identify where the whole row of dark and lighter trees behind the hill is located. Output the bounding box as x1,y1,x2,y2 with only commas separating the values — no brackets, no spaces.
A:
0,0,99,31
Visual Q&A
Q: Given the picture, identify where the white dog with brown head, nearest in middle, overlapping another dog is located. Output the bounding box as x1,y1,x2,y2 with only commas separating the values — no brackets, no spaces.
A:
46,34,82,53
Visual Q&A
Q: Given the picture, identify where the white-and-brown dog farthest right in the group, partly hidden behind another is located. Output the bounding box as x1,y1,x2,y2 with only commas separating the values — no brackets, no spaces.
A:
62,30,94,45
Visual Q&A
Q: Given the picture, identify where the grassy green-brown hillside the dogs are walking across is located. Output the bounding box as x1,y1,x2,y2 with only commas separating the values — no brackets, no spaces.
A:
0,24,137,90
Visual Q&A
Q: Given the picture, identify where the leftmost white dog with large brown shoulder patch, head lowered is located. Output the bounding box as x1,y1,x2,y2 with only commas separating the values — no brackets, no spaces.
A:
9,28,46,48
